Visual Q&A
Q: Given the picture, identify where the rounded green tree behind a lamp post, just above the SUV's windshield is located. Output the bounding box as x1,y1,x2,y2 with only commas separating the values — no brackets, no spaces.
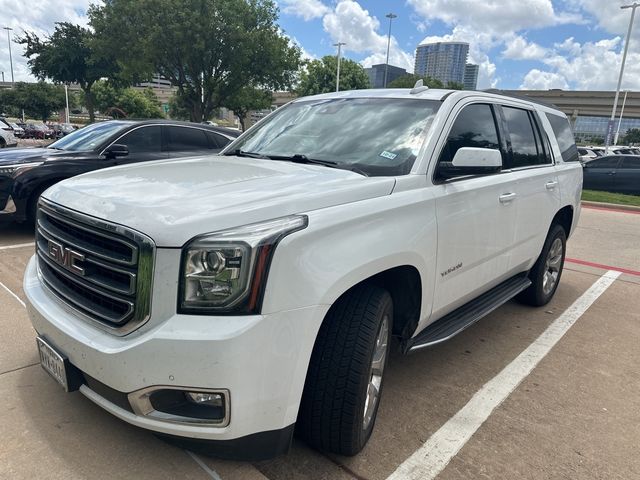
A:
296,55,371,96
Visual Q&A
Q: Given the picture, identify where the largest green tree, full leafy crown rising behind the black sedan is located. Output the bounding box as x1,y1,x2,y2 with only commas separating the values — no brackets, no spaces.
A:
89,0,300,122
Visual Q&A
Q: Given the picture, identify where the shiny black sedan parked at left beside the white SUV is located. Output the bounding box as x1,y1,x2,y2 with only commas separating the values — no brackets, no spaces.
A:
0,120,240,222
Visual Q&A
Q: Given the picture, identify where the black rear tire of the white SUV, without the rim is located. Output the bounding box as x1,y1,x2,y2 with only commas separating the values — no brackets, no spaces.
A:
516,223,567,307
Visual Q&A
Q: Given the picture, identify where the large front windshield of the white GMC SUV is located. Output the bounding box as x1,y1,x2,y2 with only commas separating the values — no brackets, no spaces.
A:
225,98,440,176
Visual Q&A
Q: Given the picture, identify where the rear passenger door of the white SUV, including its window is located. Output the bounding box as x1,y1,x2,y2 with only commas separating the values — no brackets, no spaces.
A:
501,105,560,273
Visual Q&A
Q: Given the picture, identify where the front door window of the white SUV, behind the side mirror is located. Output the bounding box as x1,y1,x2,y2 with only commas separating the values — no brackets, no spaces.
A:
439,104,500,162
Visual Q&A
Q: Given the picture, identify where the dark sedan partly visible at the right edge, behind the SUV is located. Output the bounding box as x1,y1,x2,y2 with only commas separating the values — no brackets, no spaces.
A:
583,155,640,195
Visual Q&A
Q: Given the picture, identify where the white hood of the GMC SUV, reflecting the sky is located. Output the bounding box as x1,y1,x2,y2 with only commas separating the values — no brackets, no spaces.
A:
44,156,395,247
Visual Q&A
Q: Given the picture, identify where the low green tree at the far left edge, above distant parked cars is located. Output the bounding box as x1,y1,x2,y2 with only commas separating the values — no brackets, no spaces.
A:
1,82,65,122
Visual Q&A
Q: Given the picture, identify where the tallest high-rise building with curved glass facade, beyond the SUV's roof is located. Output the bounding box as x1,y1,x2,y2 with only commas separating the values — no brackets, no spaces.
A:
414,42,469,85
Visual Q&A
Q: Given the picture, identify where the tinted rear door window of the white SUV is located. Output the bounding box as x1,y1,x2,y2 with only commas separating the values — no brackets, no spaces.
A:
502,107,547,168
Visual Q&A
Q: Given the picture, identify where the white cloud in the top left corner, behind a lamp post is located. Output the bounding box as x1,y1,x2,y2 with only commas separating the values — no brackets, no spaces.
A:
0,0,92,82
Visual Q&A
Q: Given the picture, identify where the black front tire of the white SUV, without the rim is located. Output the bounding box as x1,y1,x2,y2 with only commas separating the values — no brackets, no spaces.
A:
296,284,393,455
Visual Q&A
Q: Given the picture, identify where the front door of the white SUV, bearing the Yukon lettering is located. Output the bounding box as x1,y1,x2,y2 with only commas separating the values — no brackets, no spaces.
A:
432,103,517,319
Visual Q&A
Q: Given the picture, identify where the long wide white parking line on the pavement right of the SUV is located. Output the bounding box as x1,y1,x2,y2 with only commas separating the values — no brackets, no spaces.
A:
387,270,620,480
